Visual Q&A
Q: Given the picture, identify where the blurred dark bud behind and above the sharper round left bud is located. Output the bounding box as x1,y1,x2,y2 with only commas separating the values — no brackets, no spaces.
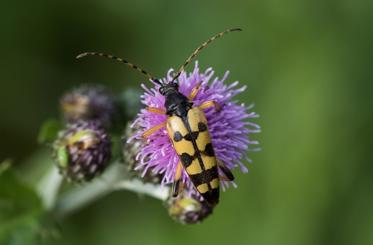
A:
60,85,118,127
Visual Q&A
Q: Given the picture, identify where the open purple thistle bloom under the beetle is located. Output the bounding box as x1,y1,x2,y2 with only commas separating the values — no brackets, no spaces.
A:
130,62,260,195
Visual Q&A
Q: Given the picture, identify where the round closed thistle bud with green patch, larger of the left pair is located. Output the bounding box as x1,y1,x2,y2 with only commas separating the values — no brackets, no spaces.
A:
54,121,111,182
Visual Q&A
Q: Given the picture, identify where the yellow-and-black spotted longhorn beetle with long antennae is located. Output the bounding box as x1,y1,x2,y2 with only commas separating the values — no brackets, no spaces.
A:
76,28,241,206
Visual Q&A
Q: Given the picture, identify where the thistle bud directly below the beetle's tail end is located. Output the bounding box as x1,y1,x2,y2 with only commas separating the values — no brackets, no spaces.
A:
167,191,213,224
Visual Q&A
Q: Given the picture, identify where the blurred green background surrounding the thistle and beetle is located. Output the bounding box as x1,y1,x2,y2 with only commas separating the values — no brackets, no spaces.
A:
0,0,373,245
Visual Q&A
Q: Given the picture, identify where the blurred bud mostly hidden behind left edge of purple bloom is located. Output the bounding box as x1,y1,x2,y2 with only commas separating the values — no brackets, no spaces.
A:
122,123,162,184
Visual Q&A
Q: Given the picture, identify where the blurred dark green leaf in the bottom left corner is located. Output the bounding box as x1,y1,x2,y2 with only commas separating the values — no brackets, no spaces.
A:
0,166,43,244
